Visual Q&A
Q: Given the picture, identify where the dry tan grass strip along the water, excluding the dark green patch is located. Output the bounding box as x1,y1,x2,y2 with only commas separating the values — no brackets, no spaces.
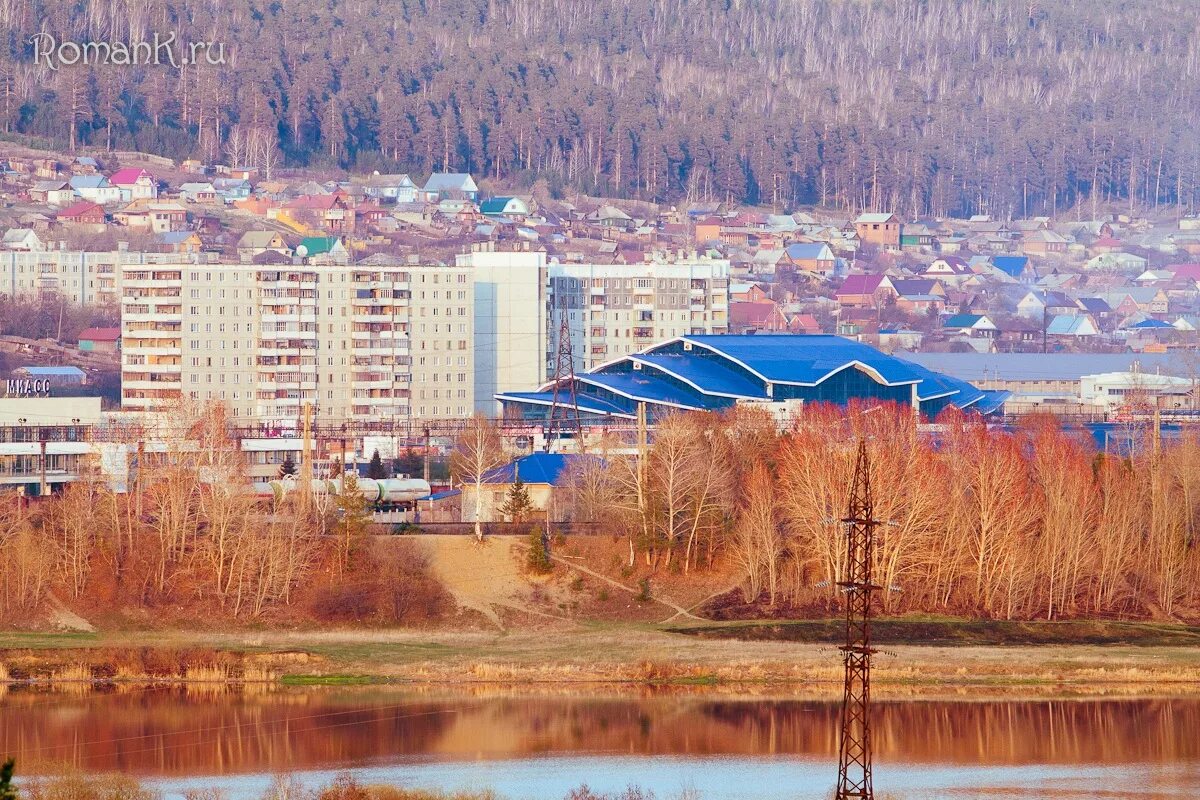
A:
7,621,1200,692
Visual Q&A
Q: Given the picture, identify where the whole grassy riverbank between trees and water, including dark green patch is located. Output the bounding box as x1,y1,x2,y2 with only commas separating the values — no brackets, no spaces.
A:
0,620,1200,691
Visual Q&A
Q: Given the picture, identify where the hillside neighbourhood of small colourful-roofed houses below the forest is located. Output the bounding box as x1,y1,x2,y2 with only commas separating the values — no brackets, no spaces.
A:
0,151,1200,357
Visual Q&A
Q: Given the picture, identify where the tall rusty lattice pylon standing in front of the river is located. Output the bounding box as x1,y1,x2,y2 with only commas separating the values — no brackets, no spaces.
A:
834,441,880,800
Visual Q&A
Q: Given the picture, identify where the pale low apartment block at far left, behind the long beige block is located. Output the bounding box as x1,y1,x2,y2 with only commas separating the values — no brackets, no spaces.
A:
0,246,194,306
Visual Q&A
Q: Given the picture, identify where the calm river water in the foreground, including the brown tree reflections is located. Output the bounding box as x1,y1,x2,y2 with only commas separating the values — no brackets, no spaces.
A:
0,688,1200,800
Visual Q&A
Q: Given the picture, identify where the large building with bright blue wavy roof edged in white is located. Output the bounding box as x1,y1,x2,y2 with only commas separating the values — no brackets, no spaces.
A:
496,335,1008,422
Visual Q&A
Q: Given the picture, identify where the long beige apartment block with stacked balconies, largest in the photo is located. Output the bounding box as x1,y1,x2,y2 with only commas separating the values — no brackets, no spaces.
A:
121,257,474,428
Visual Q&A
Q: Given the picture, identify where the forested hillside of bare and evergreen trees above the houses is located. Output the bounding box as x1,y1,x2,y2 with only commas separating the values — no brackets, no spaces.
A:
0,0,1200,216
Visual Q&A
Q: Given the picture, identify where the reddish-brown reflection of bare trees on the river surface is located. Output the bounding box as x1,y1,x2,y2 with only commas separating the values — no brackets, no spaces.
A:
0,691,1200,775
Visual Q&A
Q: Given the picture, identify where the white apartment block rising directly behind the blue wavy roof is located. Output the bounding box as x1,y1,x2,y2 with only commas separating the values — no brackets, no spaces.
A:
550,259,730,372
